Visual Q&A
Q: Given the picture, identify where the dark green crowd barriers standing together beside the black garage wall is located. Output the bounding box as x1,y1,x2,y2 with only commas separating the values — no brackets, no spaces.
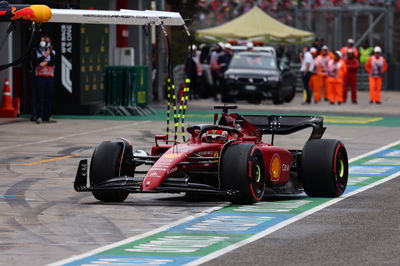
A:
101,66,154,116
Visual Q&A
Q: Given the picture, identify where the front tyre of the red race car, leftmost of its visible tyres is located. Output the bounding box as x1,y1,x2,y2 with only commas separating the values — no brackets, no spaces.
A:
90,141,129,202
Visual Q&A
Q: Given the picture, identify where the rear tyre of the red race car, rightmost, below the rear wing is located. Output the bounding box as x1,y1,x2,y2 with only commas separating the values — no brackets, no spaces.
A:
302,139,349,197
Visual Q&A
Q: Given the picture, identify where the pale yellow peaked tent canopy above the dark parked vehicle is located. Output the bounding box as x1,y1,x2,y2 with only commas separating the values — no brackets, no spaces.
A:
196,6,314,44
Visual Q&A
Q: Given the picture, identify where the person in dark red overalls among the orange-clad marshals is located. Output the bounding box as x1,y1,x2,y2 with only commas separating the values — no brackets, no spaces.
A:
343,49,360,104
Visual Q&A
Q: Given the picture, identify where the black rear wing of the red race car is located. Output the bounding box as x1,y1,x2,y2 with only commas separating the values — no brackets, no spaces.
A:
238,115,326,139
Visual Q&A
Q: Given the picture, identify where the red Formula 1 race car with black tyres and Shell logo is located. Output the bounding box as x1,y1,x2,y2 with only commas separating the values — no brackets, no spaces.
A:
74,105,348,204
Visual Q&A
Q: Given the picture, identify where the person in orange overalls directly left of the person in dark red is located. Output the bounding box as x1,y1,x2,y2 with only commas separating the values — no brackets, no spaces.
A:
328,51,347,104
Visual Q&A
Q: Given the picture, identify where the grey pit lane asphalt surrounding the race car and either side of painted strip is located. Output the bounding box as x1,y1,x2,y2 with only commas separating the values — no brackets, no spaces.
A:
0,91,400,265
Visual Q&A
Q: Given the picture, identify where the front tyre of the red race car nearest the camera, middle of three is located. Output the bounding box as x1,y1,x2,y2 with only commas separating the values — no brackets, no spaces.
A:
220,143,265,204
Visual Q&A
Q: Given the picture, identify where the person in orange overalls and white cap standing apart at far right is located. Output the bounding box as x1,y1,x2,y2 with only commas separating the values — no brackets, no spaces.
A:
365,46,387,104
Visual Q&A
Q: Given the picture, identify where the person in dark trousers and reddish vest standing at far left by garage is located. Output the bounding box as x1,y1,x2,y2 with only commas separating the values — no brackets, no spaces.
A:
32,36,57,124
